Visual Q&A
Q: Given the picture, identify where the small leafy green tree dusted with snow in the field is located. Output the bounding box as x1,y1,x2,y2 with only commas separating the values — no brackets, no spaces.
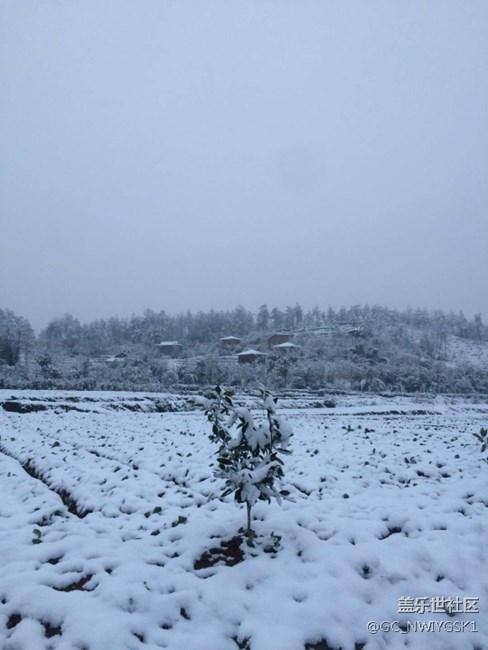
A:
193,386,293,543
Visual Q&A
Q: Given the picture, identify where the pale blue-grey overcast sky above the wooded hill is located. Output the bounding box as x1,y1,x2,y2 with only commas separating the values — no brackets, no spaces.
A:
0,0,488,328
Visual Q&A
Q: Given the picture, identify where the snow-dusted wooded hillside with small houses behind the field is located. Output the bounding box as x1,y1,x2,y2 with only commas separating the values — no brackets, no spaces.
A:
0,304,488,394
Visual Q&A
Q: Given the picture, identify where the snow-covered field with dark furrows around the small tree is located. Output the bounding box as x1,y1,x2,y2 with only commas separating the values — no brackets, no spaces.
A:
0,391,488,650
